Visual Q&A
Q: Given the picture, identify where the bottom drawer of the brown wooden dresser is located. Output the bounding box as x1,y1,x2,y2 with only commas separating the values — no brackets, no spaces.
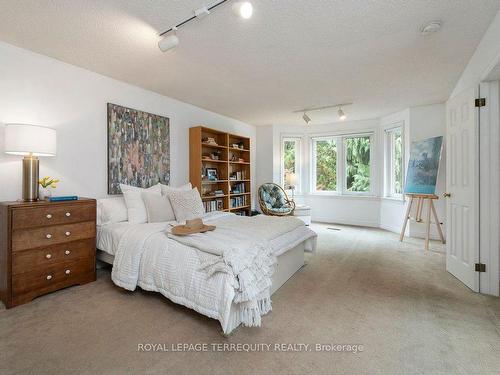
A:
12,258,95,296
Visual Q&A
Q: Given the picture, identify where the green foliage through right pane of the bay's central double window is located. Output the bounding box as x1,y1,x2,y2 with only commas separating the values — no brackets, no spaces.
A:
345,137,370,192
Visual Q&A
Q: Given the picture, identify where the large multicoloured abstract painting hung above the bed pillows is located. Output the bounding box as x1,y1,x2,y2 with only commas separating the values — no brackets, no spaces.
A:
108,103,170,194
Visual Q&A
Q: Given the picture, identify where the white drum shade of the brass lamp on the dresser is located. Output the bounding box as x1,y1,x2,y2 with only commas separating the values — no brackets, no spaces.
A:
5,124,57,156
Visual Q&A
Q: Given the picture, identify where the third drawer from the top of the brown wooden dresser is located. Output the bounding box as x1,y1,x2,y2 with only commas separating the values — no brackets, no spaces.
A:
12,238,95,275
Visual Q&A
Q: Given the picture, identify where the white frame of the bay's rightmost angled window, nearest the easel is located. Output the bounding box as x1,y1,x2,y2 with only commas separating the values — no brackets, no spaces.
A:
384,123,406,200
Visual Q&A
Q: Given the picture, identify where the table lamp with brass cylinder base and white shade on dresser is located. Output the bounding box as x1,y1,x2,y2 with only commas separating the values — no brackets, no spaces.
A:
5,124,56,202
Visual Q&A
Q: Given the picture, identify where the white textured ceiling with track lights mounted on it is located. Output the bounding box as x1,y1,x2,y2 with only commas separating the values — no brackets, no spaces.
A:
0,0,500,125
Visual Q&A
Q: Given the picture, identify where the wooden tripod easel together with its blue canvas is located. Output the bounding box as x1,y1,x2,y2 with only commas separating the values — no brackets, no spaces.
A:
399,137,445,250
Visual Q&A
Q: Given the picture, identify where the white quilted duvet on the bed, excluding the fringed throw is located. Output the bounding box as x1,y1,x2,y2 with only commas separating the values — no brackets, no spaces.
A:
108,213,316,333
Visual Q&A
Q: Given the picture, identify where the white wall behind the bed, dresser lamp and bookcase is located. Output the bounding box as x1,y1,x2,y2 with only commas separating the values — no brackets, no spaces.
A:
0,43,256,206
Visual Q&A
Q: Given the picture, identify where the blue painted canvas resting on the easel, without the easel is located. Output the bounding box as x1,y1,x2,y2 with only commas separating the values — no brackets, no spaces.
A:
405,137,443,194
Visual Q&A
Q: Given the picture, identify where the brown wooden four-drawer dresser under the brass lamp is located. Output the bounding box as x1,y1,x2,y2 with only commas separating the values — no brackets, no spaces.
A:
0,198,96,308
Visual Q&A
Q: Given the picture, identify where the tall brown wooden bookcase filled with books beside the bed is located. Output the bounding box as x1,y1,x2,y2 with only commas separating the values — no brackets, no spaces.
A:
189,126,252,216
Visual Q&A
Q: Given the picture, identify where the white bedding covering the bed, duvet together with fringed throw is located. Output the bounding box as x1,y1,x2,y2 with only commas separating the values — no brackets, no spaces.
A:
112,213,315,328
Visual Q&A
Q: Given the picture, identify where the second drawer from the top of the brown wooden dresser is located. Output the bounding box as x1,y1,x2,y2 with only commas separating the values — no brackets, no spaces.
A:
12,222,95,251
